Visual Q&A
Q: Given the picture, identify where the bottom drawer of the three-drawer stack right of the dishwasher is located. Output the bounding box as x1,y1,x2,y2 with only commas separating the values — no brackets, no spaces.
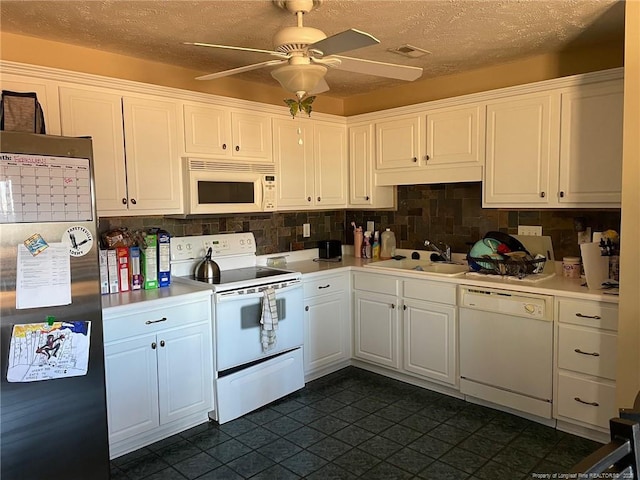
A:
557,372,617,428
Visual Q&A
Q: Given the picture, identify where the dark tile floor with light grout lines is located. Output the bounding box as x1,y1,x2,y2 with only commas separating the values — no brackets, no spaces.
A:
111,367,601,480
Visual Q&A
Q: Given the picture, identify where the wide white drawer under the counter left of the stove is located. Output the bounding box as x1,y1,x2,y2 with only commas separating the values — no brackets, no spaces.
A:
104,300,211,343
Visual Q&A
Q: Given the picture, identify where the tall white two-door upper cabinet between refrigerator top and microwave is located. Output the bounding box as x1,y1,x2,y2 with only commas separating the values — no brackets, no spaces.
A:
60,86,182,216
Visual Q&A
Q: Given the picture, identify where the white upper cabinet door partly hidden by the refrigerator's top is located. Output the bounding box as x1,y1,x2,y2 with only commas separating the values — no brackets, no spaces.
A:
60,87,128,214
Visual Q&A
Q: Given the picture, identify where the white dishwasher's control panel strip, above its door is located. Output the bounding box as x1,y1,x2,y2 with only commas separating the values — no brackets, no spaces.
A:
458,285,553,320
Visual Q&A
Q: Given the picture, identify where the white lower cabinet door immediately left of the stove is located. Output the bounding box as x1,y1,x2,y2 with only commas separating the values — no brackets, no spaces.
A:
157,323,213,424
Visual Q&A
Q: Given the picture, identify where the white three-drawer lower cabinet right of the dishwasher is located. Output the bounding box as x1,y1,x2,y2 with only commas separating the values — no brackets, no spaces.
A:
554,298,618,432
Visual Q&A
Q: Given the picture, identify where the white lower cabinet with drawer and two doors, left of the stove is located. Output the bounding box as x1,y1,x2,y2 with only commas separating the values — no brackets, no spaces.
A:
104,297,213,458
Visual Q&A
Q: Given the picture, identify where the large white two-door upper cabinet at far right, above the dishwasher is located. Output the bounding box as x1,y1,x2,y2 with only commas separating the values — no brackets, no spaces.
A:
483,80,623,208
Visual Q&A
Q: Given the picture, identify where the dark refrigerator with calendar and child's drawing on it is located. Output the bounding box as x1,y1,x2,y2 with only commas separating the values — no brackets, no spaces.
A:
0,132,109,480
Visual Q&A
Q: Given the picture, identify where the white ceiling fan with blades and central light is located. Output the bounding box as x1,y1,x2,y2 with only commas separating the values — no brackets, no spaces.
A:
185,0,422,101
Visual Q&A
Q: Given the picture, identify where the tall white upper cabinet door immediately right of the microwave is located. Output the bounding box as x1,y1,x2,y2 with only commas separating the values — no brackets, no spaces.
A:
273,119,314,208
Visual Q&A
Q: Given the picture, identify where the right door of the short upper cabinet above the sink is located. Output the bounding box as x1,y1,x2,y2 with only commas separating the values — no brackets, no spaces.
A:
426,105,485,168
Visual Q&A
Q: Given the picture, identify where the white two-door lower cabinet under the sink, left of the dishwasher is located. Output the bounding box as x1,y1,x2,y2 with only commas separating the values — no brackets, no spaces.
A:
354,273,458,386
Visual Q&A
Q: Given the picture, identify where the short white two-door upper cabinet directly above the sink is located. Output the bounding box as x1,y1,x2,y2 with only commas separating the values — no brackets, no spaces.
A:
376,103,485,185
